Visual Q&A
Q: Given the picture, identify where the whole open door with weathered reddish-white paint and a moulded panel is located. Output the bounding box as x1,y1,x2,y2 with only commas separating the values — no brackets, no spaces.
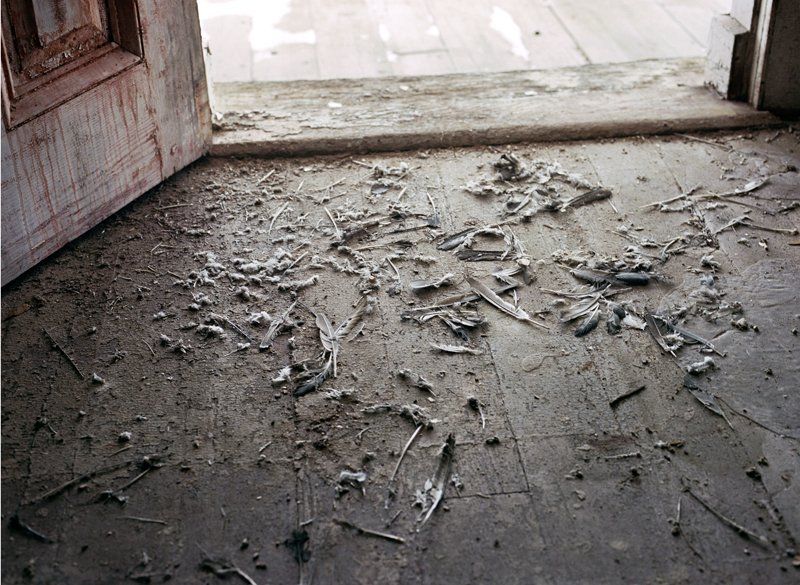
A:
2,0,211,284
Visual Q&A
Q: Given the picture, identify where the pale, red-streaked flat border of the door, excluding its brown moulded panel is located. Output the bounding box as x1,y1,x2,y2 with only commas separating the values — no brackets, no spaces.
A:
2,0,210,284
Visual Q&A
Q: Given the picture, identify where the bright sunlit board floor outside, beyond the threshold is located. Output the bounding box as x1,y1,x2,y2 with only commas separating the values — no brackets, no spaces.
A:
199,0,730,82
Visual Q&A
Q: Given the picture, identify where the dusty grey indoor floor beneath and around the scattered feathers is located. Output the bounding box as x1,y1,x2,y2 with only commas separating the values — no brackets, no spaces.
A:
2,129,800,584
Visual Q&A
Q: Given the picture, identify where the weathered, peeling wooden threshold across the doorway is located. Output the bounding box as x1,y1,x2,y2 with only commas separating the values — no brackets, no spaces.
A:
211,59,783,157
